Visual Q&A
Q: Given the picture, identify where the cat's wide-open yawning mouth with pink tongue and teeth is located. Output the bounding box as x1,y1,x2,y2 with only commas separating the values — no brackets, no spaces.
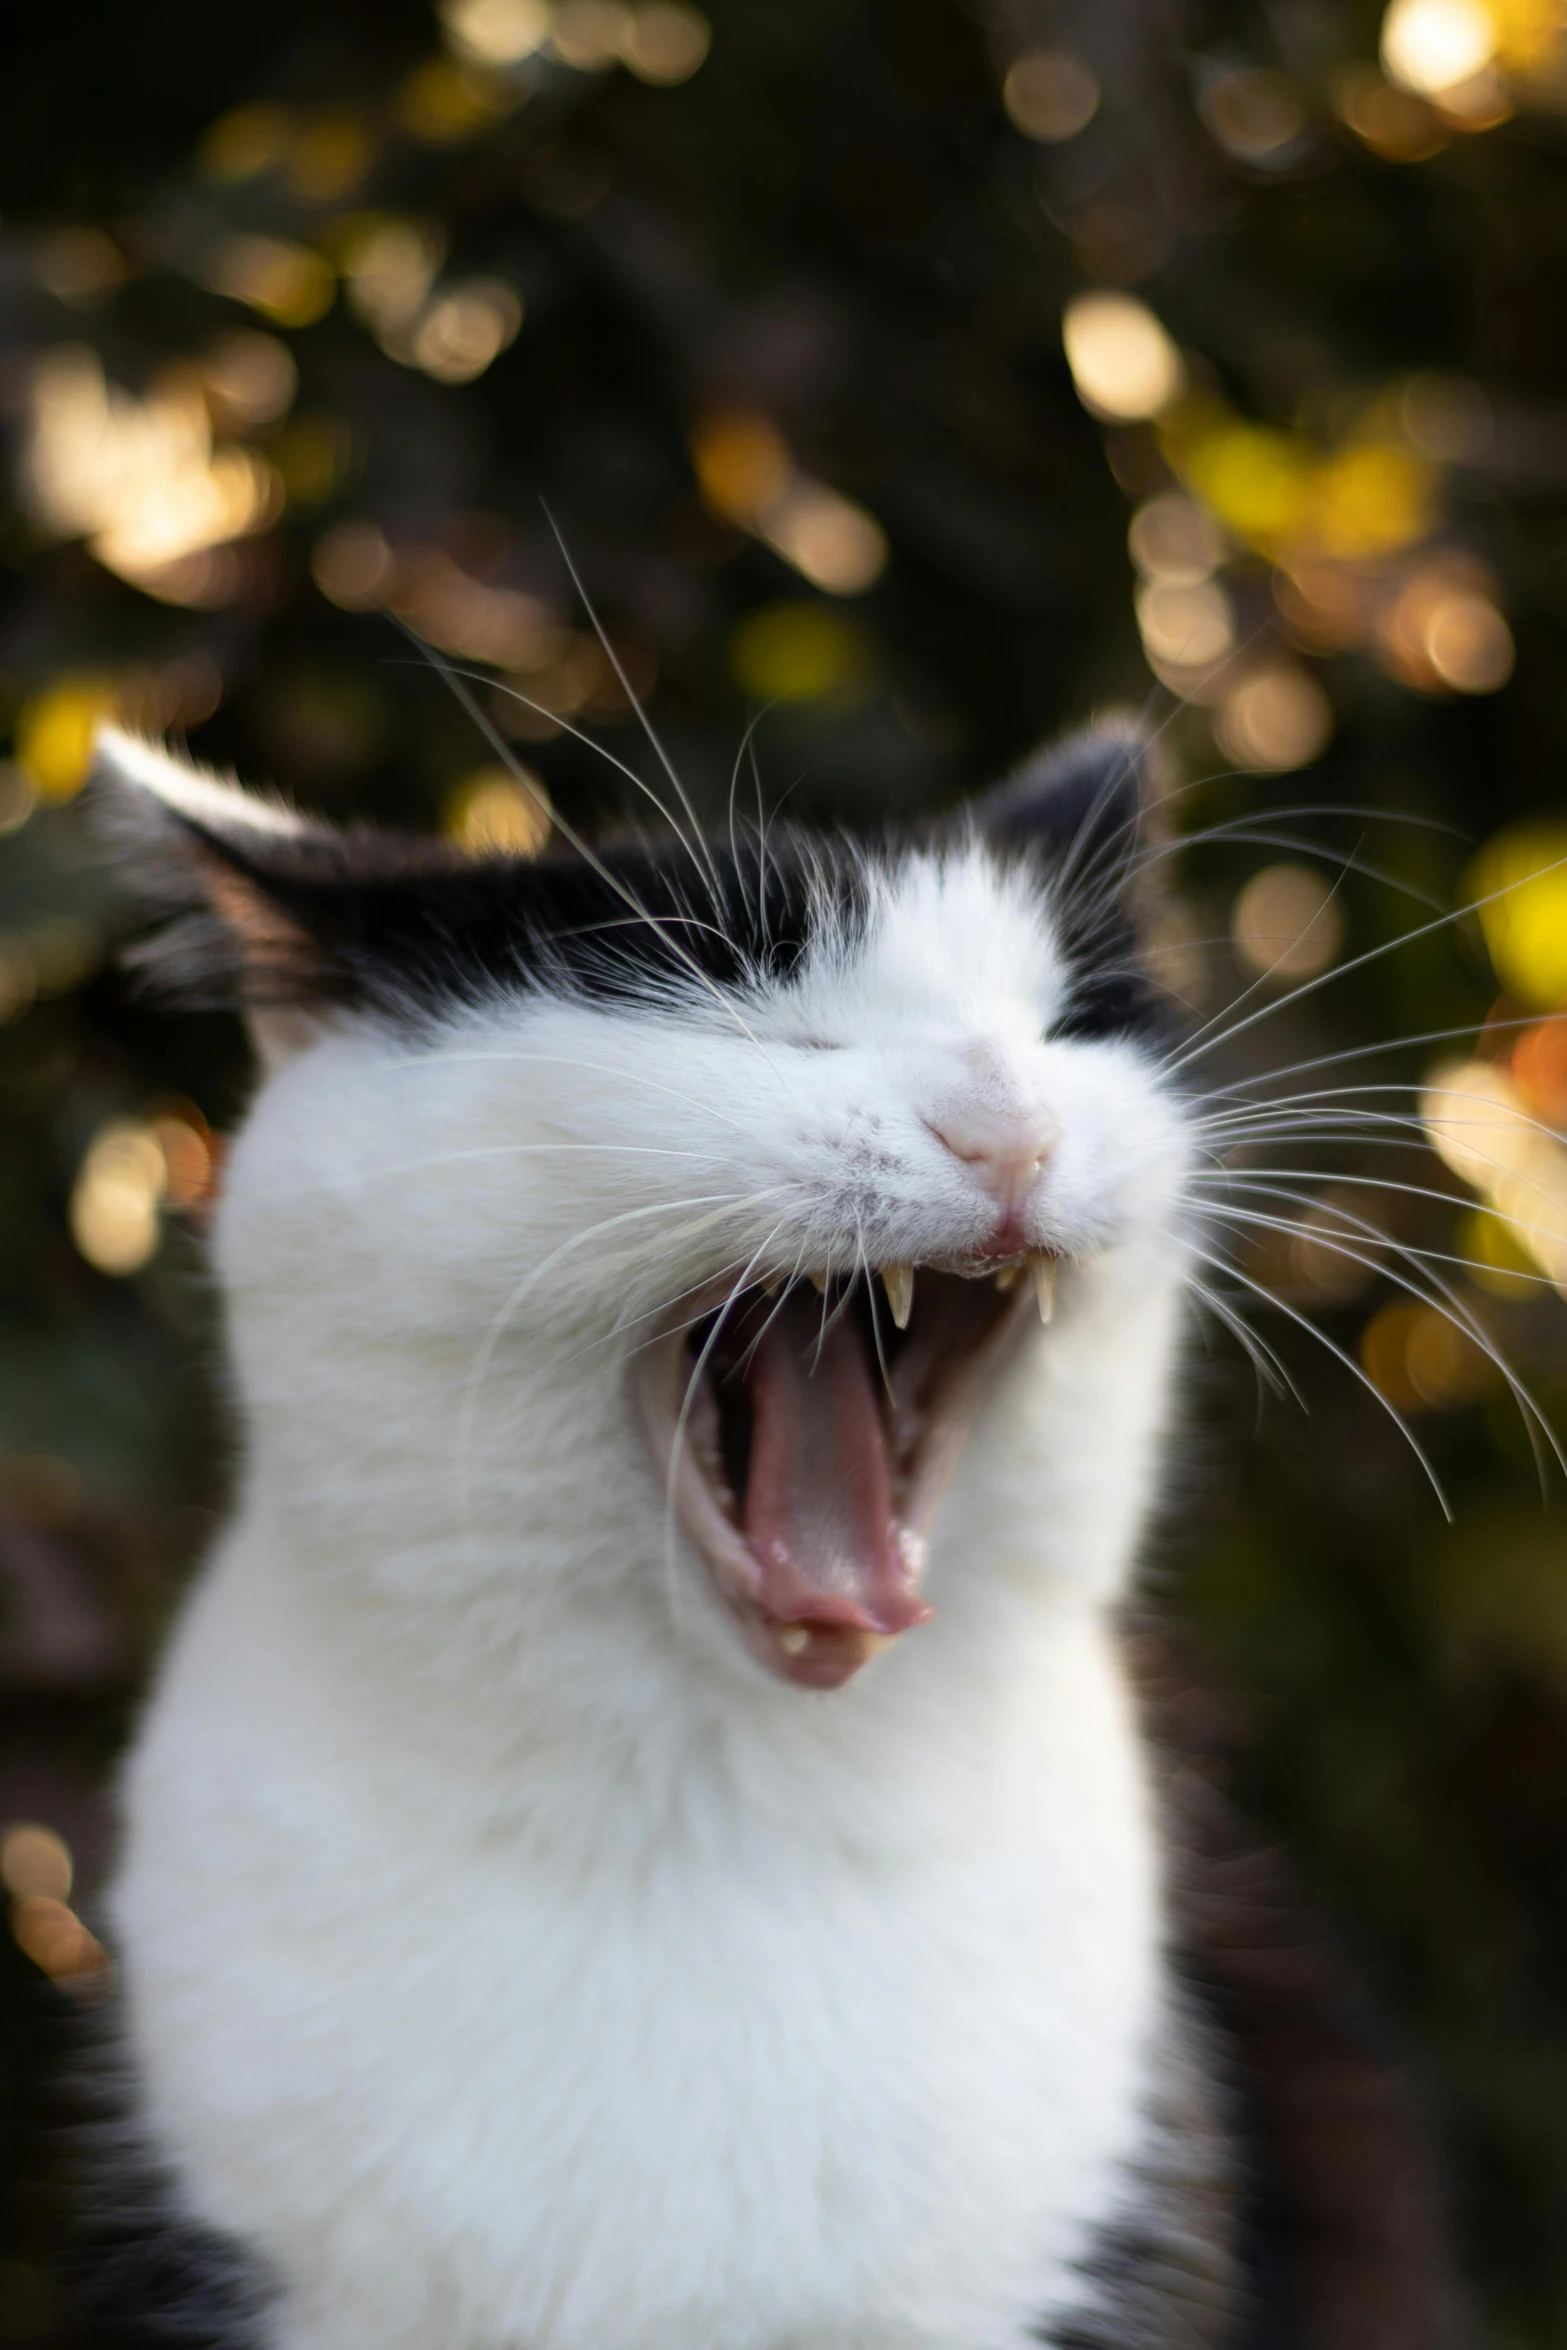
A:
637,1253,1055,1690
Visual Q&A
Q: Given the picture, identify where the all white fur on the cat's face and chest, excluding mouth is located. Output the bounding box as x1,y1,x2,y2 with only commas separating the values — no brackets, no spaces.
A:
113,817,1186,2350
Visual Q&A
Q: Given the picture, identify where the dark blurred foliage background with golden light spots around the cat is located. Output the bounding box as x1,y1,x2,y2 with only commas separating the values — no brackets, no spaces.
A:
0,0,1567,2350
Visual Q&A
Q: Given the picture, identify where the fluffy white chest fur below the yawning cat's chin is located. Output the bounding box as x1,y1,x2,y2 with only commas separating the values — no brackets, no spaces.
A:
117,1523,1158,2350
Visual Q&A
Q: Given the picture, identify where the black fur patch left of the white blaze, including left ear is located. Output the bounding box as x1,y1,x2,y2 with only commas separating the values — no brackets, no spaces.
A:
96,745,865,1020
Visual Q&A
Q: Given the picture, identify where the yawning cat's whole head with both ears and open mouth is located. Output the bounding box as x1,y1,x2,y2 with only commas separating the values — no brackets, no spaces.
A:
99,731,1186,1690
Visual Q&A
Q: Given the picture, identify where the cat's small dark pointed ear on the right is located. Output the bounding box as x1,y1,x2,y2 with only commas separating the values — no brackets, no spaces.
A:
975,719,1154,886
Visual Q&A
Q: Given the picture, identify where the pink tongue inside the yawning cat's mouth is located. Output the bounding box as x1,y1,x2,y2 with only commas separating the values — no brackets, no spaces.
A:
745,1288,930,1633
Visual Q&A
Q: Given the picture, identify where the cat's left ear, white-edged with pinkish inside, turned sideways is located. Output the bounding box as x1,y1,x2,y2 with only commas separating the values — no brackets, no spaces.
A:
92,726,345,1067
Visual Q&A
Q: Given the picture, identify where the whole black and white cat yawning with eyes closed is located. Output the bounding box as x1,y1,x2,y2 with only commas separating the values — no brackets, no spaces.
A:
76,731,1437,2350
